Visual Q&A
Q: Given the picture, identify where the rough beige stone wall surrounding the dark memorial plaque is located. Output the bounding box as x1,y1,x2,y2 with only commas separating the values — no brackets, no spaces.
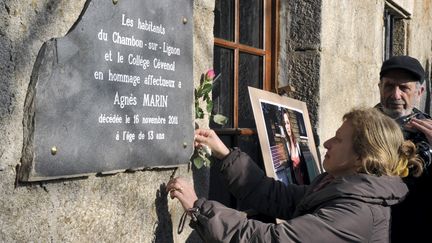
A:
0,0,214,242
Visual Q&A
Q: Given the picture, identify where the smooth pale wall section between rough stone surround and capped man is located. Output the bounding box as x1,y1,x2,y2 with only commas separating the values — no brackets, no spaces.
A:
318,1,384,151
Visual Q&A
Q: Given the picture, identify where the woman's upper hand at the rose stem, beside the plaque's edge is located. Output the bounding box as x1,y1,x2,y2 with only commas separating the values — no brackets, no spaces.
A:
195,129,230,159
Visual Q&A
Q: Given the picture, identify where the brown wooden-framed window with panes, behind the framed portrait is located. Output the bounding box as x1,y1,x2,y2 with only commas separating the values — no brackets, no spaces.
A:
210,0,278,217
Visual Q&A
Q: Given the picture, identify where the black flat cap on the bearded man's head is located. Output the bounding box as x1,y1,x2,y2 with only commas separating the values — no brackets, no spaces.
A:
380,56,425,83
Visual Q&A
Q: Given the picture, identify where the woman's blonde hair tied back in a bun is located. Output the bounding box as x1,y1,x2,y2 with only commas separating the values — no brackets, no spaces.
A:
343,108,423,177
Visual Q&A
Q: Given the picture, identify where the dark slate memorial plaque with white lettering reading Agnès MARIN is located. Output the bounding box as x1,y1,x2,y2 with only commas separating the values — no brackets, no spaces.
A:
19,0,194,181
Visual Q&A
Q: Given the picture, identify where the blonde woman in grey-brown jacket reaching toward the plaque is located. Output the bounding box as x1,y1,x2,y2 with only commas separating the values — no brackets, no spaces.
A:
166,108,422,243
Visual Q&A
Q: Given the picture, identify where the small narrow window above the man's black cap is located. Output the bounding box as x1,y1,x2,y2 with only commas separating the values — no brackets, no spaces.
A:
383,2,409,60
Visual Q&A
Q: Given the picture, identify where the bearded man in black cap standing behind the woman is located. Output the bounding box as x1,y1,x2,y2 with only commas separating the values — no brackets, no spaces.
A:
376,56,432,242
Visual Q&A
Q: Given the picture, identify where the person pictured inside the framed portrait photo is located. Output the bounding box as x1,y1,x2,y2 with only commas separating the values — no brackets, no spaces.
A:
282,109,310,185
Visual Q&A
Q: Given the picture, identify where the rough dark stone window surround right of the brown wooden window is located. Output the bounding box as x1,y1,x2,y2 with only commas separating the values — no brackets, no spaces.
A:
278,0,321,128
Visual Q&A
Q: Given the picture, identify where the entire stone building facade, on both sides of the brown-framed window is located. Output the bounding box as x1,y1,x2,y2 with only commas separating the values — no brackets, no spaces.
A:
0,0,432,242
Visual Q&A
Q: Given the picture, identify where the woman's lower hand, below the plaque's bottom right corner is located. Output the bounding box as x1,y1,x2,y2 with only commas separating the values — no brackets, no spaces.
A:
166,177,198,210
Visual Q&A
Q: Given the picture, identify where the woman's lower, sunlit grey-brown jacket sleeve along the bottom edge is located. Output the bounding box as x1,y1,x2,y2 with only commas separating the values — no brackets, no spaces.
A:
191,199,376,243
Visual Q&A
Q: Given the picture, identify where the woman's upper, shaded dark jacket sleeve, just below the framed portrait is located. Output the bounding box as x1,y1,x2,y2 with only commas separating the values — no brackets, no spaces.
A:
221,149,307,219
